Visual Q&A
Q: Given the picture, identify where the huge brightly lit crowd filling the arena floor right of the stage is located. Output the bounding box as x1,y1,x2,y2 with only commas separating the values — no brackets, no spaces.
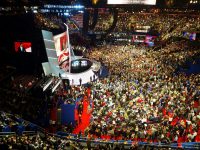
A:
81,41,200,142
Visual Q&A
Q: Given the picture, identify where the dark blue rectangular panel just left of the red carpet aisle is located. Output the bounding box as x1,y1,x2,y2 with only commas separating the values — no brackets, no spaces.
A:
61,104,75,125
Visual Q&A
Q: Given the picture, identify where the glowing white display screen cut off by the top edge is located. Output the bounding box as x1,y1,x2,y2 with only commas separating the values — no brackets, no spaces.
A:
107,0,156,5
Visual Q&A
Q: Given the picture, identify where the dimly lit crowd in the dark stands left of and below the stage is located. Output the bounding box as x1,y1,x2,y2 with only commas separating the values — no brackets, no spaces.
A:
0,71,49,127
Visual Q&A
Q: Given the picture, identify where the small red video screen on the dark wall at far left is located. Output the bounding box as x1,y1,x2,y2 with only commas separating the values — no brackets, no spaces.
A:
15,41,32,53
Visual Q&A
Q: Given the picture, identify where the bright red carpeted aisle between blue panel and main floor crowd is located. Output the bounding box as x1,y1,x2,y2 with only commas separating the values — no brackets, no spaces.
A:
73,96,91,134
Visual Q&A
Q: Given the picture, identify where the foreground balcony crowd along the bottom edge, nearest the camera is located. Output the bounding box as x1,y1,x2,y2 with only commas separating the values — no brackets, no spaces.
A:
0,133,145,150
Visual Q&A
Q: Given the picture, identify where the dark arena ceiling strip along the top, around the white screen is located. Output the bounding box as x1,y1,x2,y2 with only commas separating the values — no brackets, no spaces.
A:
0,0,200,9
